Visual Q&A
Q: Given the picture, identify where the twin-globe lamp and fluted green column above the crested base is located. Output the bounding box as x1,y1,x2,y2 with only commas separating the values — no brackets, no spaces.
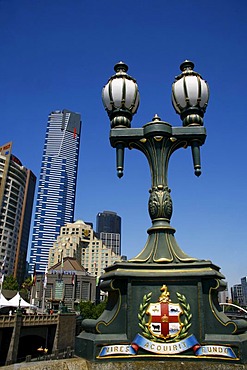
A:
102,60,209,263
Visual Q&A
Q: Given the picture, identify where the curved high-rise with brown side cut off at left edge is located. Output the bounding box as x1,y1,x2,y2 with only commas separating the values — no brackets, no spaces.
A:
0,143,36,284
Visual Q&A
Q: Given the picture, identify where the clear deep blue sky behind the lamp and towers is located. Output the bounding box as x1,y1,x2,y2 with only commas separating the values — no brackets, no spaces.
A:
0,0,247,286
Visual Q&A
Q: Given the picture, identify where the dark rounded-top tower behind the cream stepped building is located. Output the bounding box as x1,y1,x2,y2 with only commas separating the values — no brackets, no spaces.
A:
96,211,121,255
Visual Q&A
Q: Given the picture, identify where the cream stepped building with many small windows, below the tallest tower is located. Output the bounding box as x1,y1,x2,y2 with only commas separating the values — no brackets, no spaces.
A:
48,220,121,277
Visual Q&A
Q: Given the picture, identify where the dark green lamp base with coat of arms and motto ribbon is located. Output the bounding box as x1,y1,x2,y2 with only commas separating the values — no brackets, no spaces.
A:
76,261,247,363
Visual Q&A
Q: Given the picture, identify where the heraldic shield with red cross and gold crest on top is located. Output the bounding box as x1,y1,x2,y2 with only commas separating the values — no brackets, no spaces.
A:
146,285,183,339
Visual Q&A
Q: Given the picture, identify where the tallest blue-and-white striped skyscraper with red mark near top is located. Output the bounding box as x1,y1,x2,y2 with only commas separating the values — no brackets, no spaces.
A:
29,109,81,273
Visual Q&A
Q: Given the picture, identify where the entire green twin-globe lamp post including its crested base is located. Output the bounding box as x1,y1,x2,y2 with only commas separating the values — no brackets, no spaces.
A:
76,60,247,363
